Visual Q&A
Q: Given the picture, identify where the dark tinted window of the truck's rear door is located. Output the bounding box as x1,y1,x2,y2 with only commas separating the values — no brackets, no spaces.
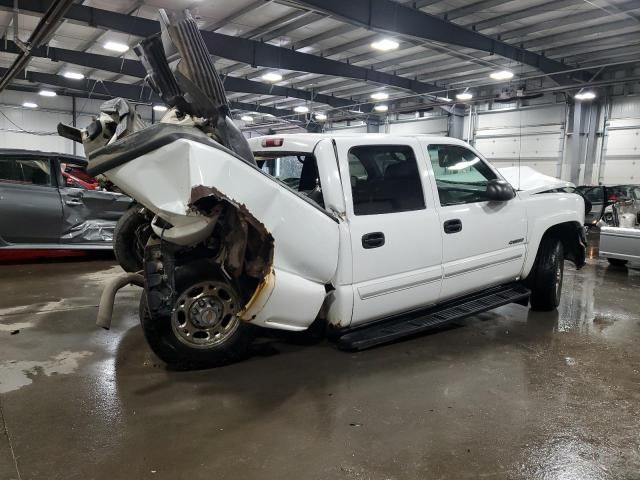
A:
348,145,425,215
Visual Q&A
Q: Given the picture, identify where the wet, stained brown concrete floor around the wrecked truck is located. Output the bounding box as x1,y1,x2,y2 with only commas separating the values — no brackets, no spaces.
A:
0,248,640,480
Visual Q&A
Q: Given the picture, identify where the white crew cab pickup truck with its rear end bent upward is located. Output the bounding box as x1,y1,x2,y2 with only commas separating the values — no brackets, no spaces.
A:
89,124,585,366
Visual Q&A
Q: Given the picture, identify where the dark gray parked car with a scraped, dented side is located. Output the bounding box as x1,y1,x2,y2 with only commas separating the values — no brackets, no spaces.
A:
0,149,131,250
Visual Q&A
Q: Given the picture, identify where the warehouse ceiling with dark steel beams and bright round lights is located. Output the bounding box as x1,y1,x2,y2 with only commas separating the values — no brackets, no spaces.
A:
0,0,640,125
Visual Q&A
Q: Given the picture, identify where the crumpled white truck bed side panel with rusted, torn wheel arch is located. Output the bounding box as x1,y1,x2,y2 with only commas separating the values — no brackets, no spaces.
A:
105,139,339,330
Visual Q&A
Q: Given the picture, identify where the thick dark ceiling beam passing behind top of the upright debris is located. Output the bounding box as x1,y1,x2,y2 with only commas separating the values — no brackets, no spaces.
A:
0,0,437,93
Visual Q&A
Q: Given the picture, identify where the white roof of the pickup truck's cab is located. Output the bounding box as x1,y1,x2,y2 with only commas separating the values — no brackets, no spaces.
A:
248,132,467,152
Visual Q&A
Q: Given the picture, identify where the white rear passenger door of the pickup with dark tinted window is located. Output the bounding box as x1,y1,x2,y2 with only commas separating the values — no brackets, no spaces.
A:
335,137,442,325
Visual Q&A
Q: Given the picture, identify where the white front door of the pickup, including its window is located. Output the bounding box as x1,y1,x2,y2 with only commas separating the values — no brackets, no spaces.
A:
423,143,527,300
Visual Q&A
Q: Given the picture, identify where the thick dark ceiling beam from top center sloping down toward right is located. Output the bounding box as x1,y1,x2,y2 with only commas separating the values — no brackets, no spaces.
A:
294,0,588,82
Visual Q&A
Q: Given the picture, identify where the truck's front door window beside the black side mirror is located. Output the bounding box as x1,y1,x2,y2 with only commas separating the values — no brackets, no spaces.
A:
428,145,497,206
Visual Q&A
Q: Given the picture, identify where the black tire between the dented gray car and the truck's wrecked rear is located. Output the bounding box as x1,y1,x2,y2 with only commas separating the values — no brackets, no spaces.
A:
113,207,151,272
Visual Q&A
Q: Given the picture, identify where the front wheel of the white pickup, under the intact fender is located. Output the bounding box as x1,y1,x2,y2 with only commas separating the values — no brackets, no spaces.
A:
528,236,564,312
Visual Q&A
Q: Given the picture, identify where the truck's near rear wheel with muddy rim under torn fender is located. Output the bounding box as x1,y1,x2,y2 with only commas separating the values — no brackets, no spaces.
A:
140,280,253,369
